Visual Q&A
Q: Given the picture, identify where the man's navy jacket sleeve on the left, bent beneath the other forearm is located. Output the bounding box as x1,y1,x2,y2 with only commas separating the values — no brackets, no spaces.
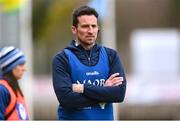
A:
52,51,97,108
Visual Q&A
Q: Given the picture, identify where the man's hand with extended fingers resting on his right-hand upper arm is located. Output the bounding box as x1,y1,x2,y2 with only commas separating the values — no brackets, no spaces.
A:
104,73,123,86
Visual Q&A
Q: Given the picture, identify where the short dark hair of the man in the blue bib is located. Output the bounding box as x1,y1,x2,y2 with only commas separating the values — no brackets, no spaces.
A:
72,6,99,27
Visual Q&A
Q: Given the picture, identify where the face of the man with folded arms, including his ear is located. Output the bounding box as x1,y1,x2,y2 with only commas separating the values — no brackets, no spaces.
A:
72,15,99,48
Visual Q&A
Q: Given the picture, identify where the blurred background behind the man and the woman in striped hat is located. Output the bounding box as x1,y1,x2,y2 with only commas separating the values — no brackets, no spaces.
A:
0,0,180,120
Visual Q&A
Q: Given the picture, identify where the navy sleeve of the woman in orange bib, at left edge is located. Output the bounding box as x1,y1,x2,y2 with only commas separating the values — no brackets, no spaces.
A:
0,84,10,120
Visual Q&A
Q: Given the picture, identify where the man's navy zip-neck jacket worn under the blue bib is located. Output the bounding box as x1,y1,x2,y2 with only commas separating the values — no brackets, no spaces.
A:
52,40,126,108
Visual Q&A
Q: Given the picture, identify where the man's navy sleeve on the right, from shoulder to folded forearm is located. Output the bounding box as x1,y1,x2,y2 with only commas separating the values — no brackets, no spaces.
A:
84,50,126,102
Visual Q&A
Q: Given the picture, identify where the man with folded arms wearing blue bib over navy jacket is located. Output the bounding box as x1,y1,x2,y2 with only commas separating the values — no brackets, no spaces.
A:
52,6,126,120
